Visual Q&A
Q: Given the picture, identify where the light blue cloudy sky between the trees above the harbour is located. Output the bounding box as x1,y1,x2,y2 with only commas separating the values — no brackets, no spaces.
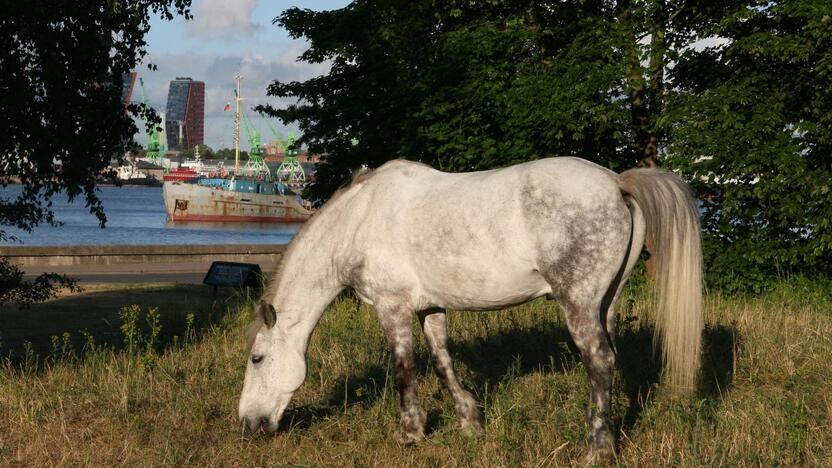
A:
132,0,350,149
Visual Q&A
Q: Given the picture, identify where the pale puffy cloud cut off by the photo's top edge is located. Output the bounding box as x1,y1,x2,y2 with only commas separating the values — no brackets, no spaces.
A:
188,0,260,38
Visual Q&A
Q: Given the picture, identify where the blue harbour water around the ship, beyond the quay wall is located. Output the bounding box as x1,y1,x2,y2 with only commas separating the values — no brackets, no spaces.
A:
0,186,300,246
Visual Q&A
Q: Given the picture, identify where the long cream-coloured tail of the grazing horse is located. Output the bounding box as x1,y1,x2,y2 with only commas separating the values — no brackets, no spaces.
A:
618,169,703,391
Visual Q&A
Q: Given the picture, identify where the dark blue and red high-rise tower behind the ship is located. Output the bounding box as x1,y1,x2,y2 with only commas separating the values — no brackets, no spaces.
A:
165,77,205,151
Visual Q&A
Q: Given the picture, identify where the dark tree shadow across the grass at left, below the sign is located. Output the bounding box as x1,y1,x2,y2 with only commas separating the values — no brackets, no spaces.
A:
0,285,250,367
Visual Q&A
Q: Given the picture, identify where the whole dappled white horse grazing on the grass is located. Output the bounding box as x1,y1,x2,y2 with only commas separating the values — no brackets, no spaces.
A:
239,157,703,460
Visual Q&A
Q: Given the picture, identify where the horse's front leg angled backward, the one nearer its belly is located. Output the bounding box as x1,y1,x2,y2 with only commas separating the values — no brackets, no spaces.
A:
419,309,484,434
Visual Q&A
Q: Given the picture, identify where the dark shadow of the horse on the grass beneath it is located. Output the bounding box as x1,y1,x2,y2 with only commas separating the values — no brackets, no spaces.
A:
258,308,738,434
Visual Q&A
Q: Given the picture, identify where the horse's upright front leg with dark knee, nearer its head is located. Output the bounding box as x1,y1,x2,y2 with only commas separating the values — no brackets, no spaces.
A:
376,305,427,445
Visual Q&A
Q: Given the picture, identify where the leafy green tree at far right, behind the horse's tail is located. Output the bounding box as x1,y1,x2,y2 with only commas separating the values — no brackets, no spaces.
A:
667,0,832,289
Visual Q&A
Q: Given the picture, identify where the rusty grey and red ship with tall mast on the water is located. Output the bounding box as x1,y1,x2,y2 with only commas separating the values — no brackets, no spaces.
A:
162,74,314,223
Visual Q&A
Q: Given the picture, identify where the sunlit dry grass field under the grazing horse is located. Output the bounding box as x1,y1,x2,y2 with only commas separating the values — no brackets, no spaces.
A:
0,282,832,466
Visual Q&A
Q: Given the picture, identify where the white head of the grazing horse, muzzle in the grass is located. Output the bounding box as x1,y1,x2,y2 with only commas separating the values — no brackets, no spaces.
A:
239,301,306,432
